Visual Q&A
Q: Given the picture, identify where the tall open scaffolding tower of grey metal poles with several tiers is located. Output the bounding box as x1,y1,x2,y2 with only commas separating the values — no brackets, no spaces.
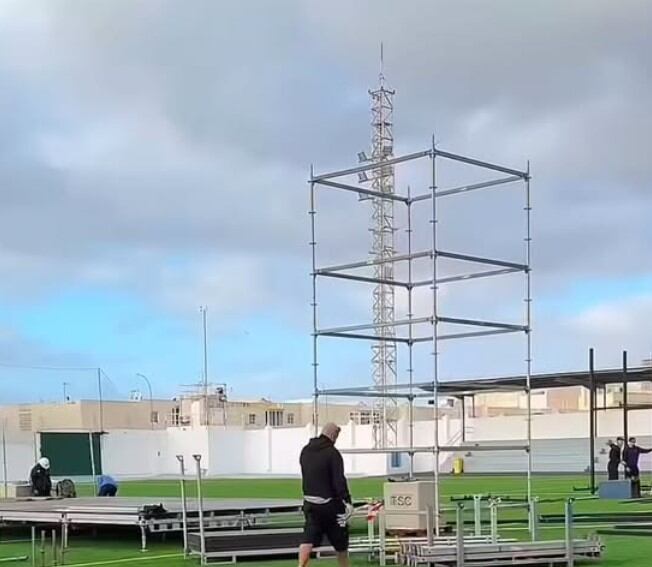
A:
309,123,532,532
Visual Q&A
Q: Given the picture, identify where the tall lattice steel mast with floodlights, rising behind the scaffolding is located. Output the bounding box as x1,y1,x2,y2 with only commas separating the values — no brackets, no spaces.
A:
361,57,398,447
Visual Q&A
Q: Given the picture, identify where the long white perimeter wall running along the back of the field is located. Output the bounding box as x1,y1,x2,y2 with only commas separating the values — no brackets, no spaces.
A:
0,411,652,481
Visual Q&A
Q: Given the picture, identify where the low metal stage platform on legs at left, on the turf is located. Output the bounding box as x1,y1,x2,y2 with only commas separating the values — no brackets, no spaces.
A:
0,497,302,548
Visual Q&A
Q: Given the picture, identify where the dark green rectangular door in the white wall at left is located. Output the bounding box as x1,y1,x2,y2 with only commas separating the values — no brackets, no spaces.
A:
41,433,102,476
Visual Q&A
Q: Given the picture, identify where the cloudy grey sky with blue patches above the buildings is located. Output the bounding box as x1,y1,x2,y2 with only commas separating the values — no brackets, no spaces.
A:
0,0,652,400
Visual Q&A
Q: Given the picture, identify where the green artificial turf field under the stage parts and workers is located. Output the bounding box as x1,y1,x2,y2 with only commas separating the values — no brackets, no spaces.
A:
0,476,652,567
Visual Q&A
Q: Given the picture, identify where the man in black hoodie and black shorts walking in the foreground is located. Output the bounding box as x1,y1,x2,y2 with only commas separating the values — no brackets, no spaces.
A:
299,423,353,567
